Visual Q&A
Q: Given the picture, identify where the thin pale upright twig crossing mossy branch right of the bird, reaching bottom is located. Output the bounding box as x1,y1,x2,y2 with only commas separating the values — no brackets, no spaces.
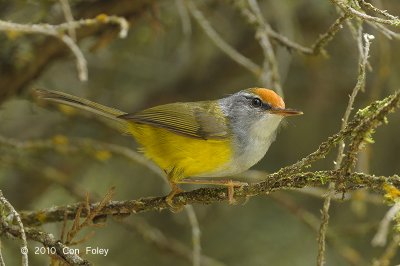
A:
317,31,373,265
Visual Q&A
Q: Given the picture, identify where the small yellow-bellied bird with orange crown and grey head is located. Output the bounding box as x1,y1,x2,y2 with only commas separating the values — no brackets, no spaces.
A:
35,87,303,207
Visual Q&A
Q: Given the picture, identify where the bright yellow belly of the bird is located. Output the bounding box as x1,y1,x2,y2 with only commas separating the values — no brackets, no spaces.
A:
130,123,232,181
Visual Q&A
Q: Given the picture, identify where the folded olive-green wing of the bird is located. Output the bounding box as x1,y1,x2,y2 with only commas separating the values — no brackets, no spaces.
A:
119,102,228,139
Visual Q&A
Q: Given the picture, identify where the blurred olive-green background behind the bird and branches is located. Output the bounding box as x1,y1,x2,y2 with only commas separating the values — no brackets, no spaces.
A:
0,0,400,265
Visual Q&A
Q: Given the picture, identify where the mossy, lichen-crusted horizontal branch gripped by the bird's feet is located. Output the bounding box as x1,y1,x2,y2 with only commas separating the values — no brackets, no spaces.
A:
20,171,400,226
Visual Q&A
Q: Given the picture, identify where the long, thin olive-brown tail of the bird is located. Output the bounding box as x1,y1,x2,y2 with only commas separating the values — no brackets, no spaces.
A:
34,89,129,133
